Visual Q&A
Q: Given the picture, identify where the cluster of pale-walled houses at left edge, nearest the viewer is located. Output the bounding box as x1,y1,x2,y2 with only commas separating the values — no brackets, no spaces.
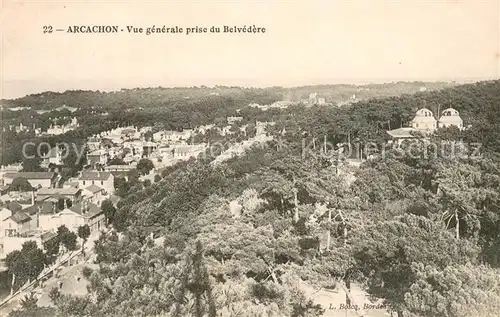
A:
0,171,118,249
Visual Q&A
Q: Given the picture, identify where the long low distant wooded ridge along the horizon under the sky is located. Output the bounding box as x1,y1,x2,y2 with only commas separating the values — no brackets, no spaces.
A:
0,82,456,109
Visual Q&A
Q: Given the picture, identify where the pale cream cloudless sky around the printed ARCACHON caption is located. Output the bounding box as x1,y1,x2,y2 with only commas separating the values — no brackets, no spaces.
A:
0,0,500,98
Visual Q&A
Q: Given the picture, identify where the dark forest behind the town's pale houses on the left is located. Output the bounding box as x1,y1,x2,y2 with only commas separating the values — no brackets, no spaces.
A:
0,88,280,165
